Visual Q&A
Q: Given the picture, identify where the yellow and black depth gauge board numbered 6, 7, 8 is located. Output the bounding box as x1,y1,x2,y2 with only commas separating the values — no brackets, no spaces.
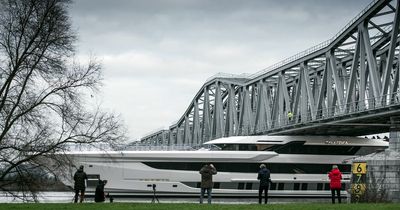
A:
351,162,367,203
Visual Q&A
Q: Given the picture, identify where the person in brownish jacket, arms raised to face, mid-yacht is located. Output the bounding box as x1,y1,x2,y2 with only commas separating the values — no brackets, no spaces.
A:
200,163,217,204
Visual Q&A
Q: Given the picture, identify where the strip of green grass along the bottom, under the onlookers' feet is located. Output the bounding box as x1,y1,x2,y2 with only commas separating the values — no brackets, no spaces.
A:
0,203,400,210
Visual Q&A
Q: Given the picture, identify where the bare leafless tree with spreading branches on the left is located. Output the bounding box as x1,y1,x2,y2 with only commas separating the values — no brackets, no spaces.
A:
0,0,123,200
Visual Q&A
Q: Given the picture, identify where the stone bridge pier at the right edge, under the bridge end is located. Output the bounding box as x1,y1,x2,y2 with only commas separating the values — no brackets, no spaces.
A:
357,116,400,202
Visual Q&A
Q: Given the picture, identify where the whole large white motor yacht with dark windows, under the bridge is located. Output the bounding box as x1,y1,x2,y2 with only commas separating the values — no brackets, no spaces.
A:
61,135,388,197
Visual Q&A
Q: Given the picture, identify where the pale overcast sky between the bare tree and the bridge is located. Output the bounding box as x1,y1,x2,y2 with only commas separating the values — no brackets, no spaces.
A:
70,0,371,140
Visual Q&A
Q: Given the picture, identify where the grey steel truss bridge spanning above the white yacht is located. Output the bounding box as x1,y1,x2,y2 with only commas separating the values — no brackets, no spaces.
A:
141,0,400,145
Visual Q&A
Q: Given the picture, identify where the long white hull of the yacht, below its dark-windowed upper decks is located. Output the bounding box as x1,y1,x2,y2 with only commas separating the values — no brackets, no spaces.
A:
64,151,351,197
